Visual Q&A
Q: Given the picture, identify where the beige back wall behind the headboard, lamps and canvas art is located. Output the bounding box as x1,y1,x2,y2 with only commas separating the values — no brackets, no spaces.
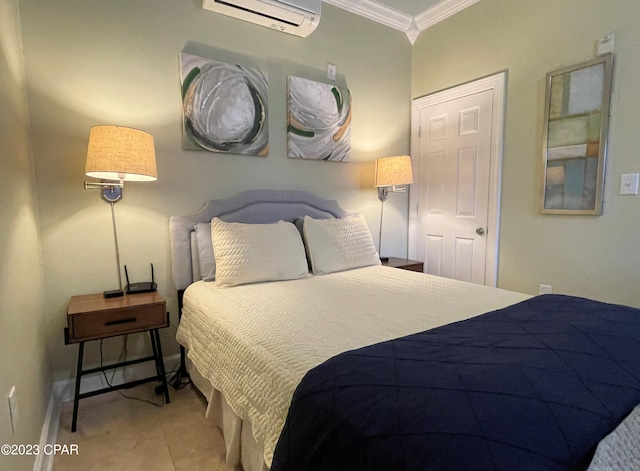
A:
20,0,411,380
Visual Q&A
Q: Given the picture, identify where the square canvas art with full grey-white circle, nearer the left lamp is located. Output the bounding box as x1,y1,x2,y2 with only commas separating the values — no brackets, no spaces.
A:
180,53,269,156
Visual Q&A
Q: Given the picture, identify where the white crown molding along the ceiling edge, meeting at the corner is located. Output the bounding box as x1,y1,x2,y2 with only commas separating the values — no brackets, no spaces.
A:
323,0,480,44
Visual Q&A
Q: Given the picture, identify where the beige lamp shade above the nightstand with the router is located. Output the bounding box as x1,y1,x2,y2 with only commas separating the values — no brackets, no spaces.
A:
85,126,158,181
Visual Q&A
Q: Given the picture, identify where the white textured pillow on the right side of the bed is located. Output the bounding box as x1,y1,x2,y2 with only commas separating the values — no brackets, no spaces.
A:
303,214,380,275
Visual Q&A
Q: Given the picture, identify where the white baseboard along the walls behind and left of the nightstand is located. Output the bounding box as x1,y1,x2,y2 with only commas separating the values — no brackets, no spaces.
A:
33,353,180,471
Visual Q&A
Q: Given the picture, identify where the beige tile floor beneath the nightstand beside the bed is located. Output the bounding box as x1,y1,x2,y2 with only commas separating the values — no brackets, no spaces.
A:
53,383,225,471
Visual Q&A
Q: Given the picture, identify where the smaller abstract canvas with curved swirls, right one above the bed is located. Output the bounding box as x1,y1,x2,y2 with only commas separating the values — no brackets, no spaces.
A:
287,77,351,162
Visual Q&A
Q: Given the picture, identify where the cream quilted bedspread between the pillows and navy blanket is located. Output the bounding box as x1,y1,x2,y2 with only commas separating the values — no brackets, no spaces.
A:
177,266,528,466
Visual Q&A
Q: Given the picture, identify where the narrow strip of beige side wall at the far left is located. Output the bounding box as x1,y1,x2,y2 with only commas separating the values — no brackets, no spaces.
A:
0,0,51,470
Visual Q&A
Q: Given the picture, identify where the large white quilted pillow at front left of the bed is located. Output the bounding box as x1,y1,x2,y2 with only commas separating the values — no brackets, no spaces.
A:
211,218,309,286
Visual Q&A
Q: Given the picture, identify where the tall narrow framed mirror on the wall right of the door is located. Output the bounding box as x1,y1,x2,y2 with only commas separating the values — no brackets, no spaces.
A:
541,54,613,216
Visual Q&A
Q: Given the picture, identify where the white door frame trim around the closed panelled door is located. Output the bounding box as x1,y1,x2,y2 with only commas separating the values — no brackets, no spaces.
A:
408,71,507,286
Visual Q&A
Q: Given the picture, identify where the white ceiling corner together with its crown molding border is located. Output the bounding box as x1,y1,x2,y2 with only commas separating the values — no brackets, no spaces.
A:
323,0,480,44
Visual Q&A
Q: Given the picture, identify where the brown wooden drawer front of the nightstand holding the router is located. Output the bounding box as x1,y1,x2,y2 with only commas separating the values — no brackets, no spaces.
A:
71,305,167,340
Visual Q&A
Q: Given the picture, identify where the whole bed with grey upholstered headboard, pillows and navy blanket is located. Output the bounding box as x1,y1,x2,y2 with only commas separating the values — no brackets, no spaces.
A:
170,190,640,471
